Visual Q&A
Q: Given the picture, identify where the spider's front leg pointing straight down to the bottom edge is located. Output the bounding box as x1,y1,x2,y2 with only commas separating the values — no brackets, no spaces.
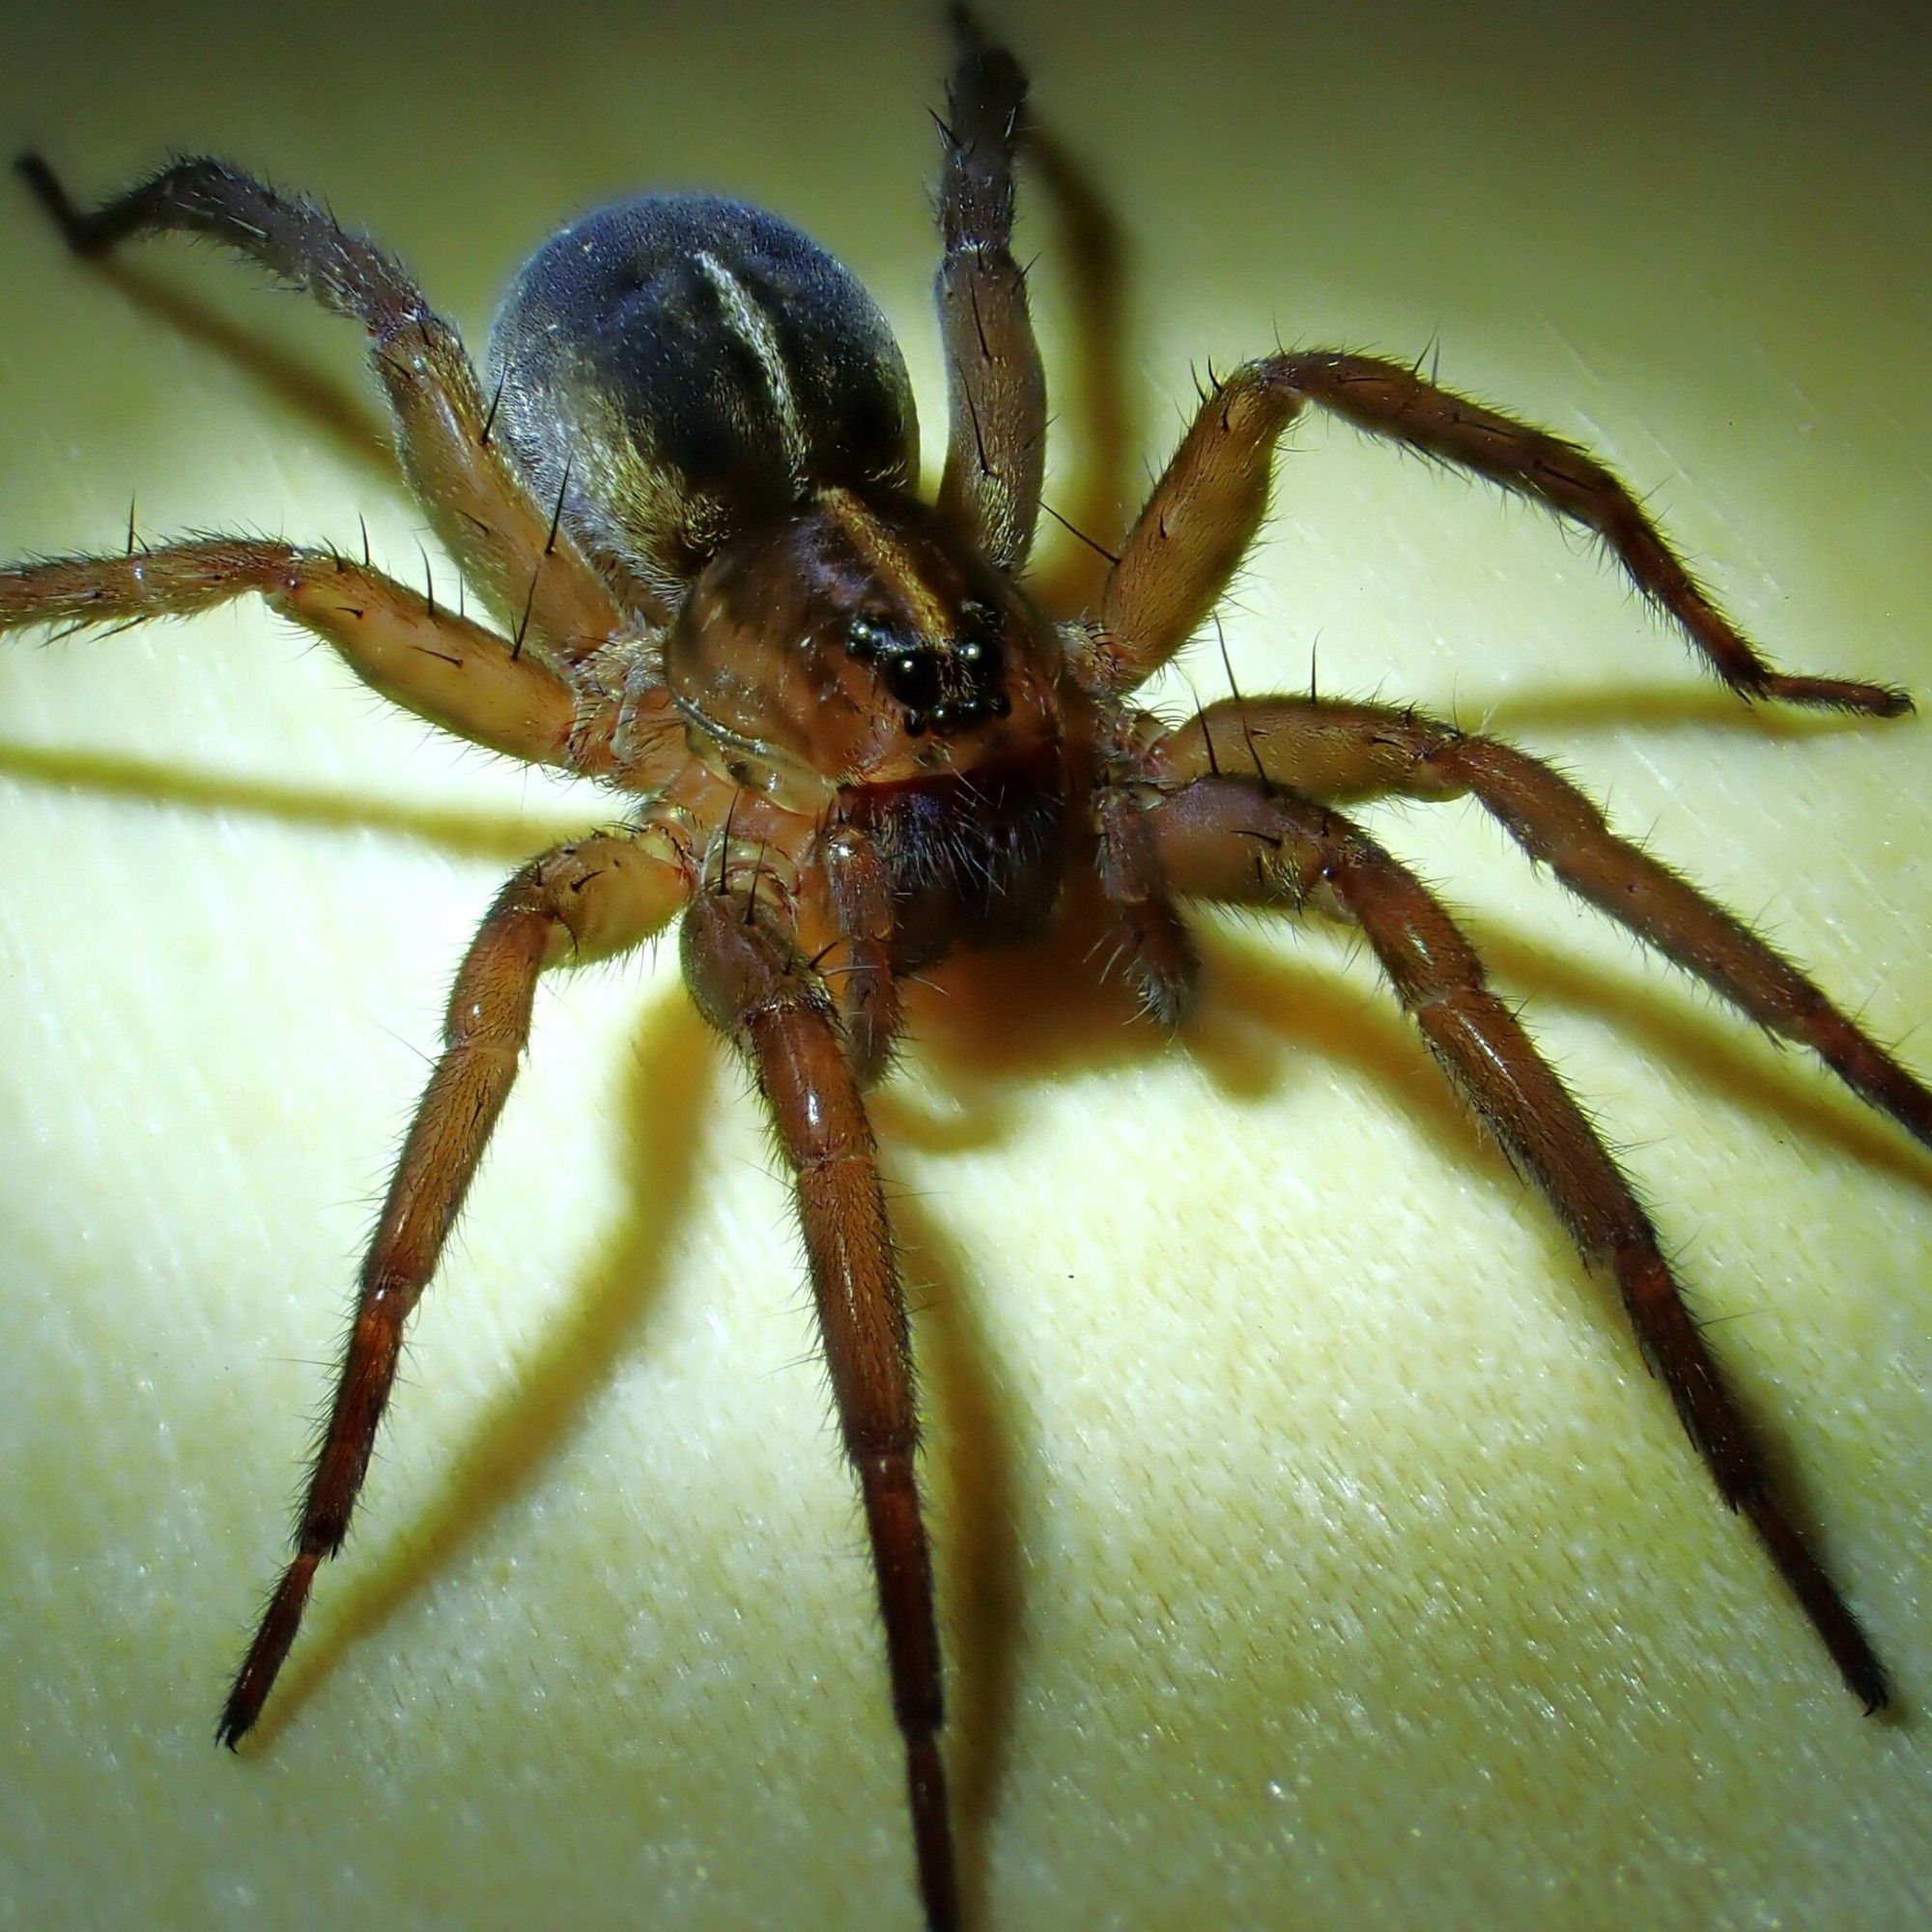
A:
684,891,958,1932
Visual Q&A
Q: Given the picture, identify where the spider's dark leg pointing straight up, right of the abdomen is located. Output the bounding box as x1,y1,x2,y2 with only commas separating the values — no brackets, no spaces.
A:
933,8,1047,570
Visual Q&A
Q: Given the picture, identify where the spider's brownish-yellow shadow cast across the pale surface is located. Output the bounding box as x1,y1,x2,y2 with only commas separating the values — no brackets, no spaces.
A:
0,265,1932,1888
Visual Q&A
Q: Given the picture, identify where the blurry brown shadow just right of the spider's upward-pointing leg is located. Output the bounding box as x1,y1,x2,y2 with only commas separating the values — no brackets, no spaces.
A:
1020,124,1140,616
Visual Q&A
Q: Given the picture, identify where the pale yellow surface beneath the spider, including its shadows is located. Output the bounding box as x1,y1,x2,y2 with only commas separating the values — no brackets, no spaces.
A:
0,4,1932,1932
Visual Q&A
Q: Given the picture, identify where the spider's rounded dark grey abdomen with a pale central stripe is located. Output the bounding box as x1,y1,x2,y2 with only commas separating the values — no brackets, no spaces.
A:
489,195,918,597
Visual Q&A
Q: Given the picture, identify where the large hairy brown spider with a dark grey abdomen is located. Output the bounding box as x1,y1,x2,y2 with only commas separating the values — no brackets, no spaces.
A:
0,17,1932,1928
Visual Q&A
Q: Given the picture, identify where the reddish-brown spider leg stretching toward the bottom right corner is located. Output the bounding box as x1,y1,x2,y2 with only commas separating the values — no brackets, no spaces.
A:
1153,777,1886,1710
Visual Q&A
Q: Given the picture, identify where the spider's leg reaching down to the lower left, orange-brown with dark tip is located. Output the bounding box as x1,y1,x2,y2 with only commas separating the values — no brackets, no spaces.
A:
216,827,692,1745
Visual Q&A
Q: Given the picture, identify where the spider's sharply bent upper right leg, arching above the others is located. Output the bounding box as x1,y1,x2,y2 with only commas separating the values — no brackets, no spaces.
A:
1084,350,1911,717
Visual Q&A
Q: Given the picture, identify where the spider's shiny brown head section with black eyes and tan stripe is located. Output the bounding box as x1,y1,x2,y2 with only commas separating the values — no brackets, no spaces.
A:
665,489,1059,811
